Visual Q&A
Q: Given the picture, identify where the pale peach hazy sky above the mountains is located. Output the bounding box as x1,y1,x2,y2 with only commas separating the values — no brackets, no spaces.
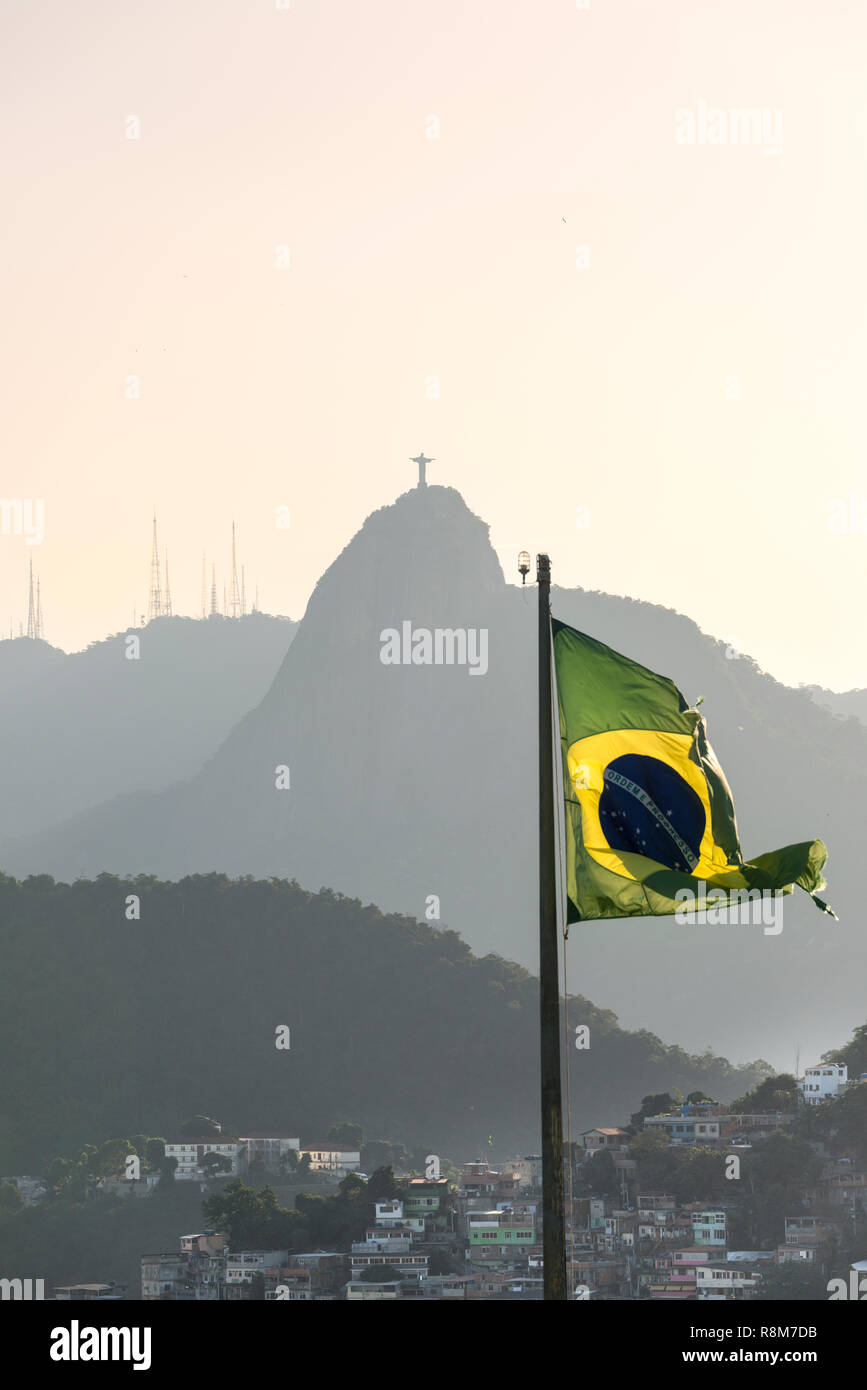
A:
0,0,867,689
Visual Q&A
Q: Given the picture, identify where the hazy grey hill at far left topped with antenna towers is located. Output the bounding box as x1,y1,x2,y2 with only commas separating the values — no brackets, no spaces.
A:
0,613,297,834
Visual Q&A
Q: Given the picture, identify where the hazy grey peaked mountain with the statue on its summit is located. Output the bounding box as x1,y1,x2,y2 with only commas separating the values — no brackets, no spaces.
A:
0,487,867,1069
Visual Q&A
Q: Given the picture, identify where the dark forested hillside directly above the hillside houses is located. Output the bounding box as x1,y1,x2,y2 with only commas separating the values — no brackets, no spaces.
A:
0,874,770,1175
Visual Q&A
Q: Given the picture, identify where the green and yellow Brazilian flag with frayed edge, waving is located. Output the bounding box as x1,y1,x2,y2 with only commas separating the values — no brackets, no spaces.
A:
552,620,831,922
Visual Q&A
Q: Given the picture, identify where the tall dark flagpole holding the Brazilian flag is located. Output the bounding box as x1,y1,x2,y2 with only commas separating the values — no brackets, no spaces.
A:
536,555,567,1302
